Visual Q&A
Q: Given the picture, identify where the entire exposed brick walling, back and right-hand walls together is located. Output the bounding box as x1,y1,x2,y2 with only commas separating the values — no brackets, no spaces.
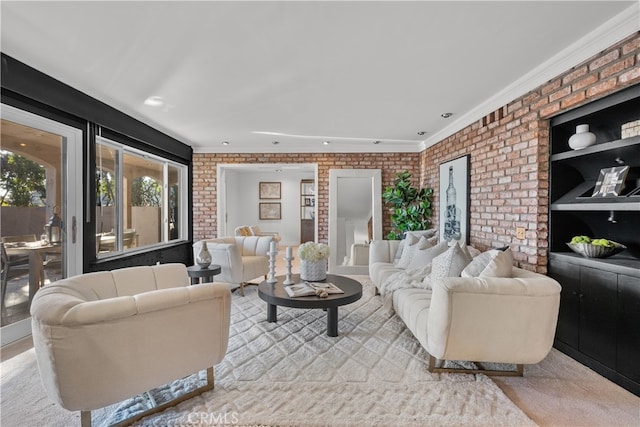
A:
193,33,640,273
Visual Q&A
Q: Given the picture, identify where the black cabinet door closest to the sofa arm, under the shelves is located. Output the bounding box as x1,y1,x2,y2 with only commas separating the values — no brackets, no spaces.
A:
549,261,580,349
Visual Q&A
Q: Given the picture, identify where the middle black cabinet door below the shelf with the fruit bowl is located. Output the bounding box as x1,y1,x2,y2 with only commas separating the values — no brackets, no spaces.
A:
580,266,618,367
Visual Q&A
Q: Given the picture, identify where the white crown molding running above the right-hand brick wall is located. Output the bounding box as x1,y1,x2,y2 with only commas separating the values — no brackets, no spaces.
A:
421,2,640,150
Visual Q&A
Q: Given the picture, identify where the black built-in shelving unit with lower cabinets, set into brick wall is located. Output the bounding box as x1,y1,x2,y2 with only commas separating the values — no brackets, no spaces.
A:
547,84,640,398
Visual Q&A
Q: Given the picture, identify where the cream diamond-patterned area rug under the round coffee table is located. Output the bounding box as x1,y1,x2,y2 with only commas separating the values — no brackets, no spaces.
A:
100,276,535,427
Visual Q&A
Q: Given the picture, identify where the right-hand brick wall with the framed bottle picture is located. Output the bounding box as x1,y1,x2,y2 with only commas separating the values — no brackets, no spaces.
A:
420,33,640,273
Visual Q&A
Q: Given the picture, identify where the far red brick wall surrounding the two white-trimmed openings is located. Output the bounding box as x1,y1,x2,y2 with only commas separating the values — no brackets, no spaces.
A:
193,153,420,243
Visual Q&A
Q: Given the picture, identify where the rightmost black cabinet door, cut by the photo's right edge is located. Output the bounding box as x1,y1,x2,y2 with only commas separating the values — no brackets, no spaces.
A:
616,274,640,382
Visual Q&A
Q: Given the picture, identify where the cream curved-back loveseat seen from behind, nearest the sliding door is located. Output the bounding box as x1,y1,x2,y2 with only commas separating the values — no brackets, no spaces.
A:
31,264,231,426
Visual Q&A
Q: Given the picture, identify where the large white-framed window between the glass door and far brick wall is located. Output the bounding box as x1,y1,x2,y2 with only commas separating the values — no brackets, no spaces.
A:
96,137,187,257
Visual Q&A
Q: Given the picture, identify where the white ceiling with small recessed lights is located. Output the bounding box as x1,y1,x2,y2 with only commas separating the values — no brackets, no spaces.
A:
0,1,640,152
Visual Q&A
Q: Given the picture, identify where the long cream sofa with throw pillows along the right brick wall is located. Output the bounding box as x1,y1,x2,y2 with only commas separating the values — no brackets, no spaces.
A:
369,234,560,375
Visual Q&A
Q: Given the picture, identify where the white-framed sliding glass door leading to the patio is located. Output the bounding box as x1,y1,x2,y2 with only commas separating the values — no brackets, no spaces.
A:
0,104,83,345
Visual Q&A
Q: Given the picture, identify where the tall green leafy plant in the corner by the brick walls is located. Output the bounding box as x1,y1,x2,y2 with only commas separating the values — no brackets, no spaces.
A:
382,171,433,240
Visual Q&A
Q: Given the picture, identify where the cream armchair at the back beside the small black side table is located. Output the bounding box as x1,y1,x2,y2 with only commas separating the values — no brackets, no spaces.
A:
193,236,273,296
